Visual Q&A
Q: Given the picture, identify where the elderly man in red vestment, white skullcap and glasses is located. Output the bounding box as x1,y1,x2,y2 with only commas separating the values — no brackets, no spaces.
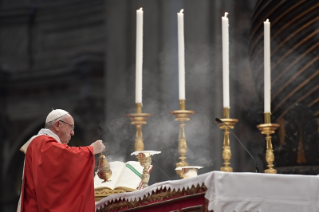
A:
17,109,104,212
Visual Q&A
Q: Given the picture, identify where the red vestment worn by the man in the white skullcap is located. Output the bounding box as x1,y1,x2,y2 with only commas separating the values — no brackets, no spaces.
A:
22,136,95,212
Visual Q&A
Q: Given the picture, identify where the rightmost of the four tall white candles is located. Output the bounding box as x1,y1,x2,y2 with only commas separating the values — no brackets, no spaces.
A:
264,19,271,113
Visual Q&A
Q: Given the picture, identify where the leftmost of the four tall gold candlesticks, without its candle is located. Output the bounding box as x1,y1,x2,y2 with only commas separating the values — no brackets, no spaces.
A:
126,103,151,157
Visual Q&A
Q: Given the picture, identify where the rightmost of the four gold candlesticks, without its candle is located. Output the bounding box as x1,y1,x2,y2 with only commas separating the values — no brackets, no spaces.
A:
257,113,280,174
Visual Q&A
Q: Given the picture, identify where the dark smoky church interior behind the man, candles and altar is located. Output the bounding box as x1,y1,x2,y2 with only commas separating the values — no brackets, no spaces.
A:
0,0,319,212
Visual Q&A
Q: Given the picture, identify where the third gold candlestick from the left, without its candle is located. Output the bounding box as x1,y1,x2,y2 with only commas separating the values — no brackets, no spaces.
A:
218,107,238,172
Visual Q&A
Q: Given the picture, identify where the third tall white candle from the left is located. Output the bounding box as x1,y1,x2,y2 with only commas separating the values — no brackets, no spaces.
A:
222,12,230,108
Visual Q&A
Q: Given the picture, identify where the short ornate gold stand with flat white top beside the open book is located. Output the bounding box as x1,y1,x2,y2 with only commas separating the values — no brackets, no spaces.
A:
131,150,161,188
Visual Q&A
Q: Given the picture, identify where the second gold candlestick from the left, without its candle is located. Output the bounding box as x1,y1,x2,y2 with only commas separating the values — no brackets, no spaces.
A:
170,100,195,178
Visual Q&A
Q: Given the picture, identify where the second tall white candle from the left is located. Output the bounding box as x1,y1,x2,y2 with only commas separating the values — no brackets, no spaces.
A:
177,9,185,100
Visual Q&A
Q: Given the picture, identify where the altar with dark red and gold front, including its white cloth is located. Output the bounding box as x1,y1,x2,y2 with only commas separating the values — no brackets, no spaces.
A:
95,171,319,212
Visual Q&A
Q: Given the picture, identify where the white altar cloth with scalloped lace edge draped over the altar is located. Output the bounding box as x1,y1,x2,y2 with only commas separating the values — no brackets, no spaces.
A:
95,171,319,212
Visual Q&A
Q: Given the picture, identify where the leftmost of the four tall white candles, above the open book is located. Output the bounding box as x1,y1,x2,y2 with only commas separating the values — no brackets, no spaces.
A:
135,8,143,103
